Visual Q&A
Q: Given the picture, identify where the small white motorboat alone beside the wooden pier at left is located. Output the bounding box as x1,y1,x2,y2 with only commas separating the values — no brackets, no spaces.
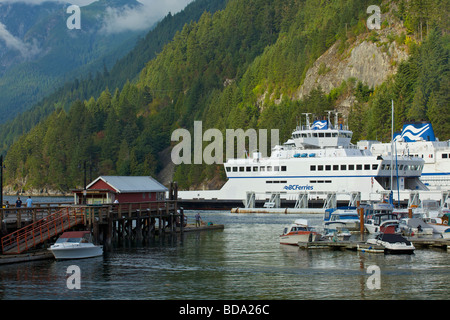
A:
48,231,103,260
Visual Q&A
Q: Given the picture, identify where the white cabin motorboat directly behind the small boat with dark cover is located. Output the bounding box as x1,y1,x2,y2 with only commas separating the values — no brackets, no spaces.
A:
364,203,399,234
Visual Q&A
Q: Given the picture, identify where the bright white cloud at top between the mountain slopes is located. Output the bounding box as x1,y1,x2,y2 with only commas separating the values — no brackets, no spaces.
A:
101,0,192,33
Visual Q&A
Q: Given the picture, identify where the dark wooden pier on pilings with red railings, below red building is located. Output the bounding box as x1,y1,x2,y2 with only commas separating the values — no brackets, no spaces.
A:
0,200,184,255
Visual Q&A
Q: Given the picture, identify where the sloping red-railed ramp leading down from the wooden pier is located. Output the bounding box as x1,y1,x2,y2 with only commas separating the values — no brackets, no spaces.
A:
1,207,85,254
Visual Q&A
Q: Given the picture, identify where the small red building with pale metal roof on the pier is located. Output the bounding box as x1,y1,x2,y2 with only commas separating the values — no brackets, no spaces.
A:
73,176,168,204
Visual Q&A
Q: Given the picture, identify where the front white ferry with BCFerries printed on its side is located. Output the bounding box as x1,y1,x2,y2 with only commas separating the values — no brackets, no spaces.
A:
178,112,427,205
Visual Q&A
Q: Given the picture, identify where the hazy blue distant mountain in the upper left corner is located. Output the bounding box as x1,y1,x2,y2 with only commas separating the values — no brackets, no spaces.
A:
0,0,146,123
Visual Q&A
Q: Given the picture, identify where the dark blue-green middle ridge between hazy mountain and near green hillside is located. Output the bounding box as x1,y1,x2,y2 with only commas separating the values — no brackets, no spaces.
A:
0,0,226,154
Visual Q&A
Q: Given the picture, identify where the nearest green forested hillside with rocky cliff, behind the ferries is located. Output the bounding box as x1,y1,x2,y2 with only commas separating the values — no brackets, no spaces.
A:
1,0,450,195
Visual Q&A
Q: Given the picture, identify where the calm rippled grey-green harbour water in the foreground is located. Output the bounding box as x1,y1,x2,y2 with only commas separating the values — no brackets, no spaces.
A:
0,211,450,300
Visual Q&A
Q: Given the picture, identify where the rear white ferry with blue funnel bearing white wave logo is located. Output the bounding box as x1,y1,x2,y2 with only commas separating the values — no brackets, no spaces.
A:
357,122,450,191
